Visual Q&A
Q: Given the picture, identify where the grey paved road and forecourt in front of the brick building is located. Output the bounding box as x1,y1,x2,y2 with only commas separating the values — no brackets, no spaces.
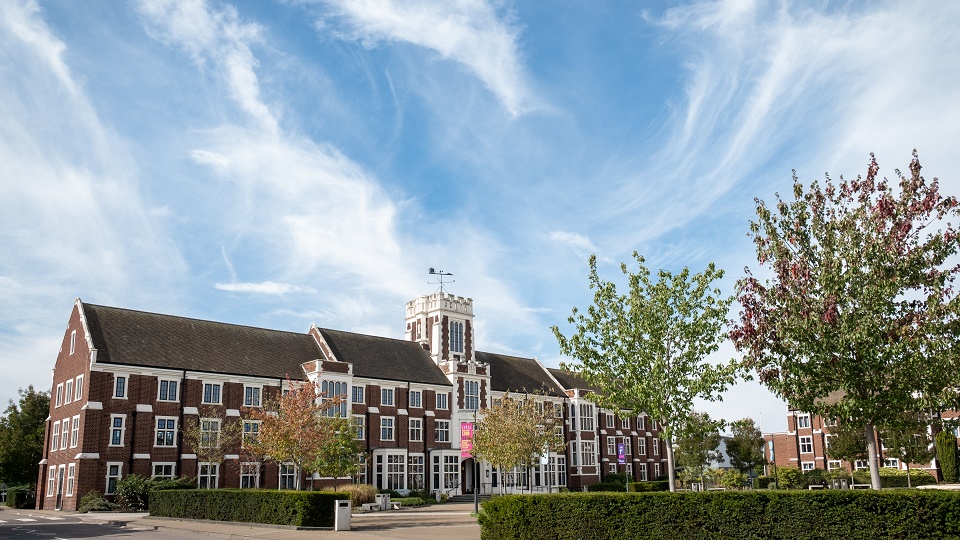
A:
0,504,480,540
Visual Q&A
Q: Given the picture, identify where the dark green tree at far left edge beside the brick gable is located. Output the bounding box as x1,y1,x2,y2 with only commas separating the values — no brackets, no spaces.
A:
0,385,50,486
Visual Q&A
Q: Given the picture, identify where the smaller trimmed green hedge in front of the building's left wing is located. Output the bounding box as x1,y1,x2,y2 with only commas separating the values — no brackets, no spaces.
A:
150,489,350,527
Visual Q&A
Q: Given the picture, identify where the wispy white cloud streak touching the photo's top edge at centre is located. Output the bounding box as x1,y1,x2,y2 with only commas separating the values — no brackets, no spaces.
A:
318,0,536,116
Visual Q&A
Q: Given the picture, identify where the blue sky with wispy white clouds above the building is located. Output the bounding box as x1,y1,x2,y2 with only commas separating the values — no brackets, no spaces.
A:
0,0,960,432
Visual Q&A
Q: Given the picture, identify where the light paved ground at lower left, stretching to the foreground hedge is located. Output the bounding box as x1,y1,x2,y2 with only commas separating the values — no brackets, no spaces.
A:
0,503,480,540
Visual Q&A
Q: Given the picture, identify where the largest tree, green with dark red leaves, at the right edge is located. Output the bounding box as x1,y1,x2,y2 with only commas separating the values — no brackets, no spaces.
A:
730,152,960,489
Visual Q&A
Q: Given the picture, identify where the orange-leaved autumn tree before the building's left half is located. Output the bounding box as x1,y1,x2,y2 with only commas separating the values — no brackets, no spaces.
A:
249,378,340,490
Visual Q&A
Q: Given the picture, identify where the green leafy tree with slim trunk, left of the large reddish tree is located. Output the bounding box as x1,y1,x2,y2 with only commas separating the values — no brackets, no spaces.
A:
553,252,738,491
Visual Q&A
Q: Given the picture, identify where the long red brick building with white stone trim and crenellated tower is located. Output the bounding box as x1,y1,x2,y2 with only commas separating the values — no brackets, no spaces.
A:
37,293,666,510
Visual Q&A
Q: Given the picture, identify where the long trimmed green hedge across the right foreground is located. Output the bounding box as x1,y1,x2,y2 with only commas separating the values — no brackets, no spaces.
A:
479,490,960,540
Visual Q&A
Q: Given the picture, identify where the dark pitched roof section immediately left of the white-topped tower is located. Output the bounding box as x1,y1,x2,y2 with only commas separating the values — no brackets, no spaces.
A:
317,328,451,386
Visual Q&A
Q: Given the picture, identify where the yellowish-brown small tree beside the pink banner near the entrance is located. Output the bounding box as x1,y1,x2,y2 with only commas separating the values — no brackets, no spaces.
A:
473,393,565,490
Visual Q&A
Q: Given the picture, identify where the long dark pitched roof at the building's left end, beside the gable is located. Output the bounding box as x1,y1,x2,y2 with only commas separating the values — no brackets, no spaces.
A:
81,303,323,379
